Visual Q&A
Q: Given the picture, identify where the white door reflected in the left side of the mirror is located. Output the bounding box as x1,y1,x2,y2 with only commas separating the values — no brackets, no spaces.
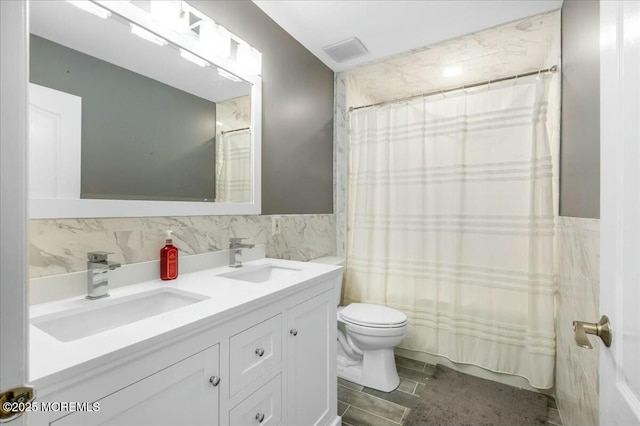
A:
28,83,82,200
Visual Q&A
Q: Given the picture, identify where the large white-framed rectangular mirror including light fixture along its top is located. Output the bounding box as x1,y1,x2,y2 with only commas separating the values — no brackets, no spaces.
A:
29,1,261,218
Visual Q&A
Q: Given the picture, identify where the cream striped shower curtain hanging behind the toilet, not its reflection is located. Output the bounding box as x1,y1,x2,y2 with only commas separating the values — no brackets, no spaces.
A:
345,75,559,388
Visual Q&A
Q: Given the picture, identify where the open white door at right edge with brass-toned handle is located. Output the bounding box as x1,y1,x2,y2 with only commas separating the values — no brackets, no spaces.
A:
594,1,640,425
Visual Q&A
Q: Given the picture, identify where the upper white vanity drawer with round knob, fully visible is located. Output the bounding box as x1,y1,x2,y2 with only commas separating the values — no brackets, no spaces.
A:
229,315,282,397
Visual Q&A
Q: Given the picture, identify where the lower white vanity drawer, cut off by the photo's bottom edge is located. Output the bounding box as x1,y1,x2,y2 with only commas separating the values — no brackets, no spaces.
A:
229,374,282,426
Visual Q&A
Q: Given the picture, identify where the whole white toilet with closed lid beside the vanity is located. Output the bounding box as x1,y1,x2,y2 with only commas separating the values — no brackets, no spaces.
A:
312,257,407,392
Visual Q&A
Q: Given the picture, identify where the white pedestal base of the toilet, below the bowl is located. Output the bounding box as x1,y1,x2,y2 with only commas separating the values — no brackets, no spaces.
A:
338,345,400,392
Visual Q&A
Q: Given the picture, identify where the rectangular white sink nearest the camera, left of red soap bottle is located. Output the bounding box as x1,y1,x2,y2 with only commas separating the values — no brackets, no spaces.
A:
31,288,209,342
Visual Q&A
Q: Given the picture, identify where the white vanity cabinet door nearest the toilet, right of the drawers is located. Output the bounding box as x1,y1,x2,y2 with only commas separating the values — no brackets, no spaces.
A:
286,291,336,426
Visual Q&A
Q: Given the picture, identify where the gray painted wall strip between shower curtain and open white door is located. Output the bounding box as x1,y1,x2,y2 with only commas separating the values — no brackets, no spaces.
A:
560,0,600,218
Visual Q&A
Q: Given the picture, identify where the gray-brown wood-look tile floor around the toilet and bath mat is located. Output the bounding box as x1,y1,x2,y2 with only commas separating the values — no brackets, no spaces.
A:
338,357,562,426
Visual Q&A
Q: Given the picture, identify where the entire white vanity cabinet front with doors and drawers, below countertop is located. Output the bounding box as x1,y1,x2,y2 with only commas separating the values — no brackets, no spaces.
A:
28,271,341,426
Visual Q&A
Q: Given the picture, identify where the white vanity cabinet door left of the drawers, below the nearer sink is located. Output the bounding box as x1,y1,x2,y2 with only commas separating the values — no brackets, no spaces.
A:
52,345,220,426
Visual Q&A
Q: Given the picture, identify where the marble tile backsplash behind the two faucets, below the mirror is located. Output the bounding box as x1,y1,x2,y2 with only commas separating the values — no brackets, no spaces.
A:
28,214,336,278
